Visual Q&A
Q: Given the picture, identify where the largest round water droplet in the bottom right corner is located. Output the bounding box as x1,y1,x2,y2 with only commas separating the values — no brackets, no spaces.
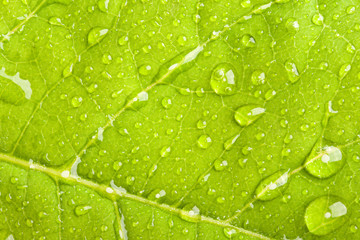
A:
304,195,349,236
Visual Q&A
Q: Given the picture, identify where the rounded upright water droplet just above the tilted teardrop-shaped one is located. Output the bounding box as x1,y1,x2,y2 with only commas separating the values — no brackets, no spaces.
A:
210,63,237,95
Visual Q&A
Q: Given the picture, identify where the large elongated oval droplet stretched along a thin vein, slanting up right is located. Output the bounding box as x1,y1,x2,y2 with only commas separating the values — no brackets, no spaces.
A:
255,171,289,201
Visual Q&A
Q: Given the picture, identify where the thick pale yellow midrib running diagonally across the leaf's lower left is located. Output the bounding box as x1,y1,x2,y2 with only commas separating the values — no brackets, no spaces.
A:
0,153,271,240
